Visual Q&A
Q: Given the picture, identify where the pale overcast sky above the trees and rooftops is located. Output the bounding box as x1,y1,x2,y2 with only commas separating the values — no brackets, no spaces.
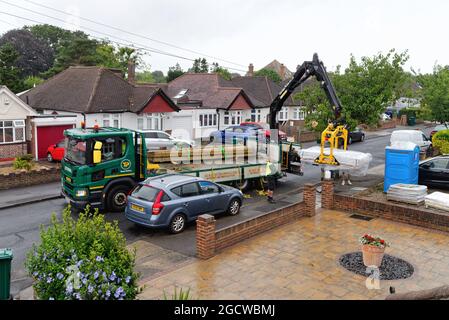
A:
0,0,449,73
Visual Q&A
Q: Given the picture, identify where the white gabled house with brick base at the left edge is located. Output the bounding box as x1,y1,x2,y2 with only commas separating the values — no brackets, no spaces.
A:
0,86,37,161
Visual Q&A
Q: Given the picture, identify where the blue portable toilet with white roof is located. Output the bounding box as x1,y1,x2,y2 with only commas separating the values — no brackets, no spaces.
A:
384,142,420,192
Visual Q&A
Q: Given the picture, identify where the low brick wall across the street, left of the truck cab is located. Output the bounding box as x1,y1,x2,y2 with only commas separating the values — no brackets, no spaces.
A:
0,168,61,190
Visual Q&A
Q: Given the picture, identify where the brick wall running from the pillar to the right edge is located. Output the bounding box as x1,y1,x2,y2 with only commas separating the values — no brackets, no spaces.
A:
334,194,449,232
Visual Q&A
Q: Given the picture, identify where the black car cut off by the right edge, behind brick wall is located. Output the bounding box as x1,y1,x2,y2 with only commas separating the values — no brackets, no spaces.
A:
419,156,449,189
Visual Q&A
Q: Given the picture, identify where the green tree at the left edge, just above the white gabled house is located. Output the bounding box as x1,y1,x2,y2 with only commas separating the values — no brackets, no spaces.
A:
0,43,24,93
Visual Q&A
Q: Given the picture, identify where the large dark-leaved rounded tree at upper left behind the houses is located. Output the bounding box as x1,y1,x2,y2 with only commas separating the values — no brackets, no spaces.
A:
0,29,54,77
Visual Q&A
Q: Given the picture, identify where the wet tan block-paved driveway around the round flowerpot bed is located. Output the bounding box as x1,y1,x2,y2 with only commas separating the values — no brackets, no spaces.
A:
138,210,449,299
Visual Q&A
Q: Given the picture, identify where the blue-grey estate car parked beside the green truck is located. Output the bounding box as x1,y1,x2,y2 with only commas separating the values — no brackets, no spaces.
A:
125,174,243,233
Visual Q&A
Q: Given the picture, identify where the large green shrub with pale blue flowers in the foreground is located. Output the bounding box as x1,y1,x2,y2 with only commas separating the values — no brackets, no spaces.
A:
25,207,140,300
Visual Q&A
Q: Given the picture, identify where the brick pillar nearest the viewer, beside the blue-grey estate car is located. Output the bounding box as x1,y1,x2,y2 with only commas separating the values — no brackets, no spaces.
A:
196,214,215,259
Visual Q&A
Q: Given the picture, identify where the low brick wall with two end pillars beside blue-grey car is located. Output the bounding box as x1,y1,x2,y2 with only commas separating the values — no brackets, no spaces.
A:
196,184,316,259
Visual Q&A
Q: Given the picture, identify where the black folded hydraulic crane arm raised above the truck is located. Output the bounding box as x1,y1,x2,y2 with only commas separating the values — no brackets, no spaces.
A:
269,53,342,130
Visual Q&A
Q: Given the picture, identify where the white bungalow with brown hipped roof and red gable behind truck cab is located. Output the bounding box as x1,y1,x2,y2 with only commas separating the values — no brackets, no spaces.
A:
20,67,179,158
